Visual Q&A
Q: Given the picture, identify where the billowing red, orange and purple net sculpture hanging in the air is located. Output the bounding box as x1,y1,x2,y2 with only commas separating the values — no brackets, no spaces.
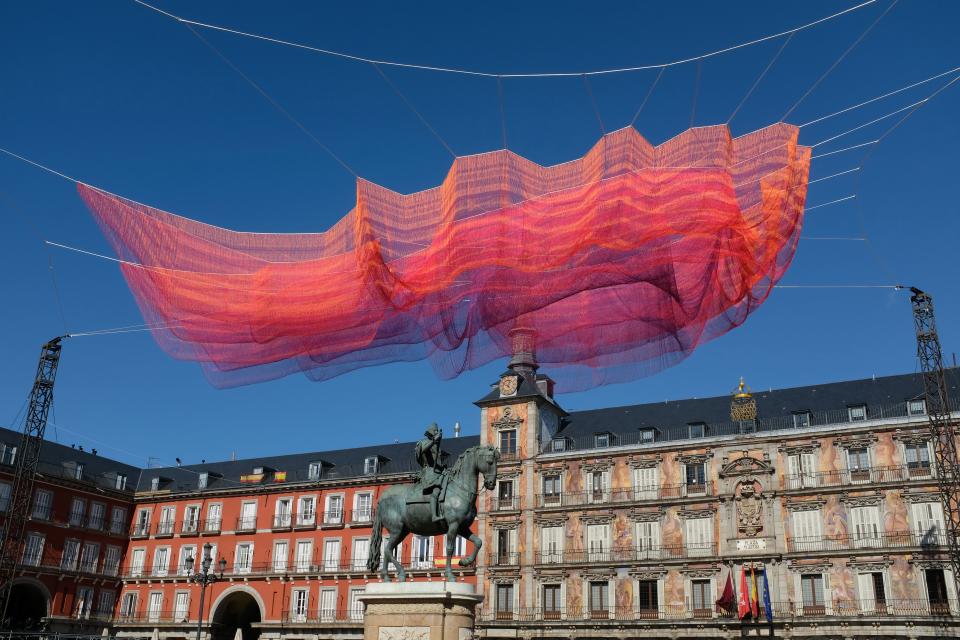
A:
79,123,810,391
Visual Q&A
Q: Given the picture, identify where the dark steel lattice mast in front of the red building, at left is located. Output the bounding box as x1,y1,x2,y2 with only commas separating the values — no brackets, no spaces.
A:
0,337,63,620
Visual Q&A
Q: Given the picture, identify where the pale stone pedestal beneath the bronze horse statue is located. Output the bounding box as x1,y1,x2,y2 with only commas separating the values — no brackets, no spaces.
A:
360,582,483,640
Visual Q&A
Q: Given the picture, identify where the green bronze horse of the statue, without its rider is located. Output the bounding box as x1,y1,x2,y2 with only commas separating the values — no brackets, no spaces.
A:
367,446,500,582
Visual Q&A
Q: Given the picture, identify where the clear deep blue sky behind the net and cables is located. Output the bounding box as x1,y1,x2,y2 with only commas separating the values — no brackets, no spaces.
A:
0,0,960,464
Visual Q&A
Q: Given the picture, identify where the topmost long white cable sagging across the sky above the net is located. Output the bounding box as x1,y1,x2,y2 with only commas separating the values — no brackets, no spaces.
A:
133,0,877,78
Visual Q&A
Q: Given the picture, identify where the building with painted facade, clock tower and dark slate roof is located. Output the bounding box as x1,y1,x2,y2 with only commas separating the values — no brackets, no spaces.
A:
477,352,960,638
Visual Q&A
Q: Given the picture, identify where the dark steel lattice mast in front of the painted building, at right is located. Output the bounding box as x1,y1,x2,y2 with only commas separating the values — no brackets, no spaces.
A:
910,287,960,593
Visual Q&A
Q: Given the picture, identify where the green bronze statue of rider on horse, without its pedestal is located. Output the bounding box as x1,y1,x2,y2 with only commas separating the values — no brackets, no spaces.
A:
367,424,500,582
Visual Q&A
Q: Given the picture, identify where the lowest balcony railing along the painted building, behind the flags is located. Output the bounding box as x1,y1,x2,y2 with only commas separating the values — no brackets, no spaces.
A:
478,600,960,626
